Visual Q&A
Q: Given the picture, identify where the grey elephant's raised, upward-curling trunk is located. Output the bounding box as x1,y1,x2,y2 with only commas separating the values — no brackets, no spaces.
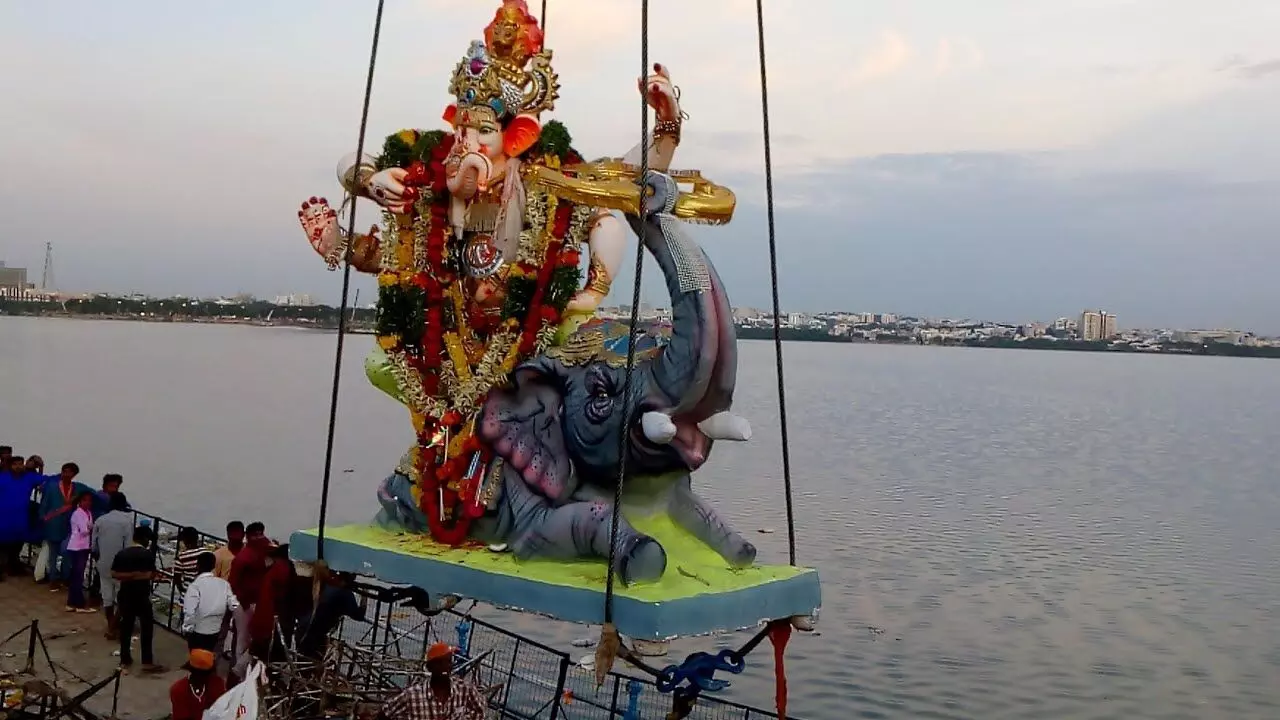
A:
628,174,737,469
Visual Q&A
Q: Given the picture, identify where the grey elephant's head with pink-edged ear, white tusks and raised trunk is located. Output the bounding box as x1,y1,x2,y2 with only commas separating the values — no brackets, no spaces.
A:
477,173,750,500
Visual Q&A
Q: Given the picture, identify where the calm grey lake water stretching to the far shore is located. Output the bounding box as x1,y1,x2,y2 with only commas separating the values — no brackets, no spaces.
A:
0,318,1280,720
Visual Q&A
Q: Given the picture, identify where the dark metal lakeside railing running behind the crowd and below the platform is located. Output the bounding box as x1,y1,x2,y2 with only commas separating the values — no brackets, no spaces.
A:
28,497,777,720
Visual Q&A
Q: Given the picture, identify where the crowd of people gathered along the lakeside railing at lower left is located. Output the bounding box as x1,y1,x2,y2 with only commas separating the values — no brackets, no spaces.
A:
0,446,486,720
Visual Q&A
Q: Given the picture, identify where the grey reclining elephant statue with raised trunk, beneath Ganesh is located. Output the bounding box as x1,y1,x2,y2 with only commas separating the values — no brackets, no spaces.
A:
379,173,755,583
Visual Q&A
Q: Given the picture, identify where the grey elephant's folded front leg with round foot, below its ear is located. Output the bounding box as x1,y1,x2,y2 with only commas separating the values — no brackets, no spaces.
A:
503,468,667,584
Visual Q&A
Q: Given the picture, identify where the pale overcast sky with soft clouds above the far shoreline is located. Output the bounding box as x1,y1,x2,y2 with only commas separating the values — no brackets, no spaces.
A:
0,0,1280,332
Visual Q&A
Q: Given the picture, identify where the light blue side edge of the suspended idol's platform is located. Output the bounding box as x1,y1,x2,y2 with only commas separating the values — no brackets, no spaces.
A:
289,530,822,641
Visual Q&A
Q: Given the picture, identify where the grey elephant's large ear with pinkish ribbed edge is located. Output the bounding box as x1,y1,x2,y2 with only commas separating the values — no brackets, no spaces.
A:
476,366,577,505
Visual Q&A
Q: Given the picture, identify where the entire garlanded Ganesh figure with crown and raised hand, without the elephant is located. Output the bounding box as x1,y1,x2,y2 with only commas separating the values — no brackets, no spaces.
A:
298,0,745,556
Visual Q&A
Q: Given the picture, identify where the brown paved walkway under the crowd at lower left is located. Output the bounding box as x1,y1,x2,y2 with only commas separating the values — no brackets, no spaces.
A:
0,577,187,720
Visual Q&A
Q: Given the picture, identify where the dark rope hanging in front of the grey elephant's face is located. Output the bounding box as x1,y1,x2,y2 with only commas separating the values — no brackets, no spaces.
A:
604,0,649,623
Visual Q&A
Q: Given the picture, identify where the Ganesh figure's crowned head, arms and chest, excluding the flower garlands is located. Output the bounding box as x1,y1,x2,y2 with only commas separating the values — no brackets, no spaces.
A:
298,0,684,316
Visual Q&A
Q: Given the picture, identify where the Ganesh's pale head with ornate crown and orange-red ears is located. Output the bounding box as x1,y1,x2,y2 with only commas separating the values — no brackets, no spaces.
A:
444,0,559,202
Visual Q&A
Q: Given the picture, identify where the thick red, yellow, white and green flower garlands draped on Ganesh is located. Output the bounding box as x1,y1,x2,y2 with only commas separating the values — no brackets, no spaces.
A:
376,120,591,546
